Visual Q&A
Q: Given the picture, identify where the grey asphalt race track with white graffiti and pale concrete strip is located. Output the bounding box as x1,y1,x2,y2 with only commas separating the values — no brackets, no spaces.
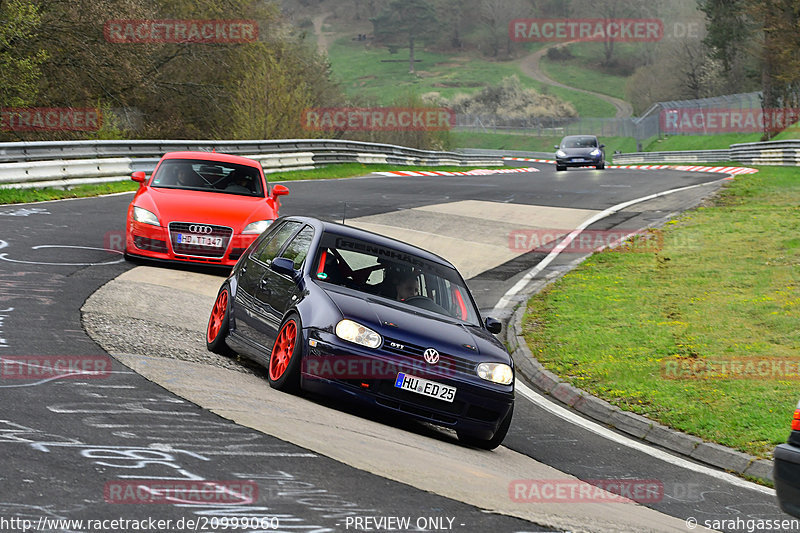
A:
0,165,789,532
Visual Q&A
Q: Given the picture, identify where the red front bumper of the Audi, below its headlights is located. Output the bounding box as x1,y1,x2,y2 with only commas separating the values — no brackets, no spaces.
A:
125,221,253,266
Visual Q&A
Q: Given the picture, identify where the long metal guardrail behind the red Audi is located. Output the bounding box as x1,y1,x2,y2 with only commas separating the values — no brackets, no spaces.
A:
0,139,503,188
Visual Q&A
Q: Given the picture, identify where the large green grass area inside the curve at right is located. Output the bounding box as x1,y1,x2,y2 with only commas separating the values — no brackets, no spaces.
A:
525,167,800,457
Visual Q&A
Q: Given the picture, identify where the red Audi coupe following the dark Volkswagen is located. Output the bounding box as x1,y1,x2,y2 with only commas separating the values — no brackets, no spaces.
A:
125,152,289,266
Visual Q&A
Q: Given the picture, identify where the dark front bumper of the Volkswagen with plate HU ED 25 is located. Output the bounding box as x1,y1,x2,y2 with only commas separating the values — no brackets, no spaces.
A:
301,329,514,439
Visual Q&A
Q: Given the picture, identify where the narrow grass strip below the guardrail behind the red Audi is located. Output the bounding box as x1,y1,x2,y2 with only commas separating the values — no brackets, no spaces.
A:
0,163,500,204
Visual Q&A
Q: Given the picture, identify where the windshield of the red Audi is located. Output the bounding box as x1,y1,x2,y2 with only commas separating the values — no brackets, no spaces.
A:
151,159,264,197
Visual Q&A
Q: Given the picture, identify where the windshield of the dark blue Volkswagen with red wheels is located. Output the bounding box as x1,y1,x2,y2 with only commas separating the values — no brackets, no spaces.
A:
312,233,480,326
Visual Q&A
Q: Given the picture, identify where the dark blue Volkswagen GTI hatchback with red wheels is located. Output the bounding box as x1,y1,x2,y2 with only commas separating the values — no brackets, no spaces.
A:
206,217,514,449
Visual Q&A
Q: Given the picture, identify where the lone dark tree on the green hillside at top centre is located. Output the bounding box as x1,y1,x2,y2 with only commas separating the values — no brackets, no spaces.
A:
370,0,439,74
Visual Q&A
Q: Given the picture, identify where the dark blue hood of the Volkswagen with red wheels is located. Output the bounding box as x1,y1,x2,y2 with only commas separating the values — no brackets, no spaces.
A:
325,286,510,362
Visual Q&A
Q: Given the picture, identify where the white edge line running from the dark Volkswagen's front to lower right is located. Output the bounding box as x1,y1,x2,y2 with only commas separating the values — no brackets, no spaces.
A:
514,380,775,496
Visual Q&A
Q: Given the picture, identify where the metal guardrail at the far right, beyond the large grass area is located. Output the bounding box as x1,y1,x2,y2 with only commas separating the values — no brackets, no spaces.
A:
614,139,800,166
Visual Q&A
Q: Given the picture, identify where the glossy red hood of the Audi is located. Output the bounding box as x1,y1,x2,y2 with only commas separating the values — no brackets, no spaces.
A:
134,188,277,233
